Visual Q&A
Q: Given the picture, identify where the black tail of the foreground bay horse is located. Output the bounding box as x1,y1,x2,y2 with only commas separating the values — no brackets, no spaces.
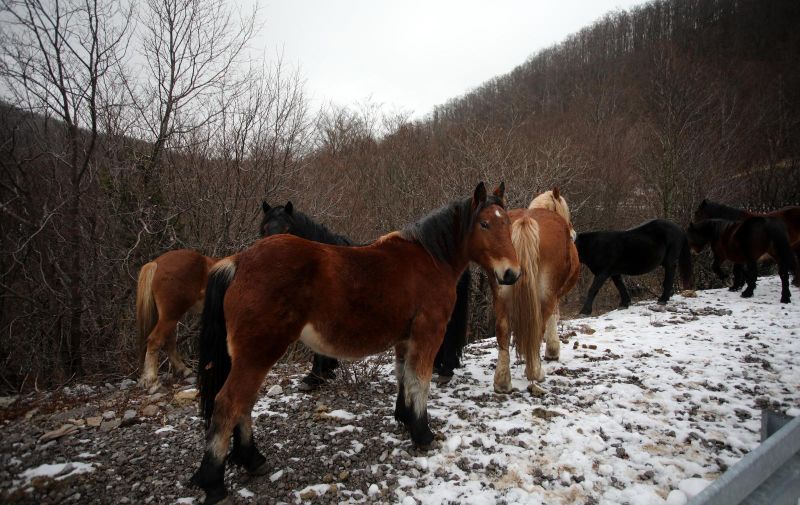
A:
197,258,236,427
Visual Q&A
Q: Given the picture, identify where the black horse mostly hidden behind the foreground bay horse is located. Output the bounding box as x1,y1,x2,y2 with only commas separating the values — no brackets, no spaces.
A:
259,202,471,391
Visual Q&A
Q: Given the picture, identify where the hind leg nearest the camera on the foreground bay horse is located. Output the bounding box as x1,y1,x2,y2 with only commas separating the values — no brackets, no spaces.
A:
191,355,272,504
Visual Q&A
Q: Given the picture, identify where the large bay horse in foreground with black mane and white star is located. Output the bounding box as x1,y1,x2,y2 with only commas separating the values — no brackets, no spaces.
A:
192,183,520,503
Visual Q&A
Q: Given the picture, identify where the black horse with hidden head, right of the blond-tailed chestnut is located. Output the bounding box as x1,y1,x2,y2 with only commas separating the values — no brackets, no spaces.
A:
575,219,692,315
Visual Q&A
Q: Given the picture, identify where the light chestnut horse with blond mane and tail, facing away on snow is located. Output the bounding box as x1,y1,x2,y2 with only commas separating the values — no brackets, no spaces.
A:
491,189,580,393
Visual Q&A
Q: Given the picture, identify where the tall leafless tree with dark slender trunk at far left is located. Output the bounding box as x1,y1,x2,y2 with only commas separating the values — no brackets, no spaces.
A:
0,0,130,373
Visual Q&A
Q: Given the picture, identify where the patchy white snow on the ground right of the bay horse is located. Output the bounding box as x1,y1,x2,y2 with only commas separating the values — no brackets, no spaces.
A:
256,277,800,505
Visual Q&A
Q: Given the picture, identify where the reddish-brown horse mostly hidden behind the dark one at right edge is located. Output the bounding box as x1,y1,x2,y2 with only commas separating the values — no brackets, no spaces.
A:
694,199,800,284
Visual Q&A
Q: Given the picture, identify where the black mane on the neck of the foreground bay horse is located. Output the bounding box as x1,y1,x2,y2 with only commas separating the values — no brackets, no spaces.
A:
400,195,505,263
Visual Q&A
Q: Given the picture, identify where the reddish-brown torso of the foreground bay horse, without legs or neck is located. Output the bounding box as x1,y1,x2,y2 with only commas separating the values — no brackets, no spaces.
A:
225,235,456,357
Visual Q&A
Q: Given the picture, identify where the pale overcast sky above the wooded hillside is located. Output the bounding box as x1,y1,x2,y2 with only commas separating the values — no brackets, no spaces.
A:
253,0,643,118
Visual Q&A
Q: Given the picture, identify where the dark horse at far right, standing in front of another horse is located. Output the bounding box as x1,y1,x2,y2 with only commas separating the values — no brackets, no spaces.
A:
686,216,797,303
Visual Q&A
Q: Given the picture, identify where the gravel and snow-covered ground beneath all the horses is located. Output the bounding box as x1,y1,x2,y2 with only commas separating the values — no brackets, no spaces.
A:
0,278,800,505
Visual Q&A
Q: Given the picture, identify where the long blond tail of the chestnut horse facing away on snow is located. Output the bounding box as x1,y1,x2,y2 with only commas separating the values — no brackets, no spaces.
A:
508,217,544,374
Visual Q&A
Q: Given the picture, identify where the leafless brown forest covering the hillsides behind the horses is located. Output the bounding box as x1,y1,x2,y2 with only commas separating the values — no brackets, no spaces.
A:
0,0,800,391
